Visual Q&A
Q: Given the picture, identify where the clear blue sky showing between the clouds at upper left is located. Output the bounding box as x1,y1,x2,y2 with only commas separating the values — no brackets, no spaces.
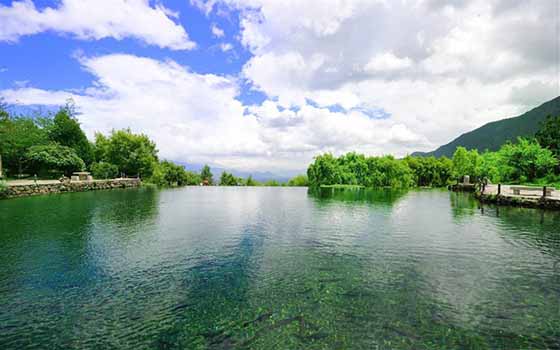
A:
0,0,263,104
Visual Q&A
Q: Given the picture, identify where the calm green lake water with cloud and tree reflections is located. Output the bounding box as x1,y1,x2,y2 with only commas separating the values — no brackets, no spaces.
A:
0,187,560,349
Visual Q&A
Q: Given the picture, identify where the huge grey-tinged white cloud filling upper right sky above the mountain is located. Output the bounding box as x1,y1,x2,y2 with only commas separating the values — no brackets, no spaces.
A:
202,0,560,150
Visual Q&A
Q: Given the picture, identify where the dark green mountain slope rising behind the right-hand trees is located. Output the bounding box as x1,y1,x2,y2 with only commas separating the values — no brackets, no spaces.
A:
412,96,560,157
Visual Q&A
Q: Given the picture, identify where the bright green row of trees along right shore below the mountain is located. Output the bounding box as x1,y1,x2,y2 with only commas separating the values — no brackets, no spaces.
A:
307,117,560,188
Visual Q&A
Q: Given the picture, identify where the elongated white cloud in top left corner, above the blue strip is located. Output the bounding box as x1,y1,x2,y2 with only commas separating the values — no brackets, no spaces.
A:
0,0,196,50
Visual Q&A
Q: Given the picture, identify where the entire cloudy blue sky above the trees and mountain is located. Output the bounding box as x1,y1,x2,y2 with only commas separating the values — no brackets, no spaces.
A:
0,0,560,174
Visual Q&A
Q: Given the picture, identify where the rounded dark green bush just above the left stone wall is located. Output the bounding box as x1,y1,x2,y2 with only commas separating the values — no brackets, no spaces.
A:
25,143,85,176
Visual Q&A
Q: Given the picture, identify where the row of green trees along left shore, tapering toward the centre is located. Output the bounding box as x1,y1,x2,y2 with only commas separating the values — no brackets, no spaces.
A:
0,101,307,186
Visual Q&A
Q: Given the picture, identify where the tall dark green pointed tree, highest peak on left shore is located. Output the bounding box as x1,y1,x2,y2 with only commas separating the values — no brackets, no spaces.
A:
48,101,94,165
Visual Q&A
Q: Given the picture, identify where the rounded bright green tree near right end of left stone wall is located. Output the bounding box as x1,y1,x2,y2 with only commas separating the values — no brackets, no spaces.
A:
95,130,158,178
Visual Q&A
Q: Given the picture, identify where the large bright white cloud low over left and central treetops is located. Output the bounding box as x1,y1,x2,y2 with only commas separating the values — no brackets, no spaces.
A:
0,54,426,171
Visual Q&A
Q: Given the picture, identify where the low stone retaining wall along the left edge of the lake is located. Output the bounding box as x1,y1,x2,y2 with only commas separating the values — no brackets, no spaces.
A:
0,179,142,198
